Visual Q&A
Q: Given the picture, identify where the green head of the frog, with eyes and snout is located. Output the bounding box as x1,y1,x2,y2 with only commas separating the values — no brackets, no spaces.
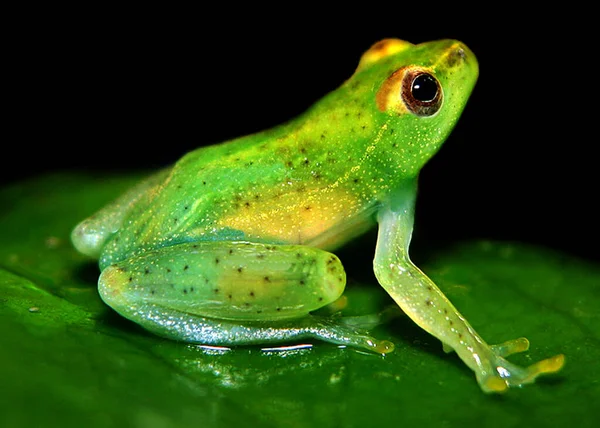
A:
350,39,478,177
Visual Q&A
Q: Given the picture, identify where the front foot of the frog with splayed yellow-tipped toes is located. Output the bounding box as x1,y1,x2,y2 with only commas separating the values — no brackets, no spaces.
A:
476,337,565,392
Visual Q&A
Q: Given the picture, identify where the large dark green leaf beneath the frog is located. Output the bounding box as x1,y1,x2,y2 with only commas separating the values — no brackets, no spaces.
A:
0,174,600,427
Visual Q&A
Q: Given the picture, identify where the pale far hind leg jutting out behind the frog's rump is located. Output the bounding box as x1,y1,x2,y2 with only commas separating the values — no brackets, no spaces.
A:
71,168,170,258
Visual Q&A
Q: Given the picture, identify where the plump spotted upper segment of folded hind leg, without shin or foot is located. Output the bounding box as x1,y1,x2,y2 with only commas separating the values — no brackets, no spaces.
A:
99,241,346,322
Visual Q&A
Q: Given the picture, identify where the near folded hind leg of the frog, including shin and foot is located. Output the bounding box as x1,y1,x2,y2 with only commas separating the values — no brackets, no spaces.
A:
99,241,393,353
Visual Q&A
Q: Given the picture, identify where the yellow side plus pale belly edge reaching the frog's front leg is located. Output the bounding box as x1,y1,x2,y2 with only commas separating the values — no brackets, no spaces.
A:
213,191,375,249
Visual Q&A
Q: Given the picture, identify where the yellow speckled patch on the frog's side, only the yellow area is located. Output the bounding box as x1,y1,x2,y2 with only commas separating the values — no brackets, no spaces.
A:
217,188,358,243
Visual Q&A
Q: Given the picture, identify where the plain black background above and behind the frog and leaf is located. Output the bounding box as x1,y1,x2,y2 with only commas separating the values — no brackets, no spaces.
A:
1,2,600,260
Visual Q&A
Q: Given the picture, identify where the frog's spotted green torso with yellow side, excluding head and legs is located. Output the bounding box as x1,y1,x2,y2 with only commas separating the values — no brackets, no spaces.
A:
100,101,384,266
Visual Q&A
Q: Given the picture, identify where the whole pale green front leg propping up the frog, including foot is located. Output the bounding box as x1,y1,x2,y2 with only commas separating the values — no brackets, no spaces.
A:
374,192,564,392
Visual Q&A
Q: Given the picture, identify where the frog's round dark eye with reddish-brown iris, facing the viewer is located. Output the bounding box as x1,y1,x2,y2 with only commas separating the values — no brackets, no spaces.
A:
401,70,442,116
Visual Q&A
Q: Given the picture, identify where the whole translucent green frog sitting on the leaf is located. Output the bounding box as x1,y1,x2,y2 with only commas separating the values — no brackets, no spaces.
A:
72,39,564,392
